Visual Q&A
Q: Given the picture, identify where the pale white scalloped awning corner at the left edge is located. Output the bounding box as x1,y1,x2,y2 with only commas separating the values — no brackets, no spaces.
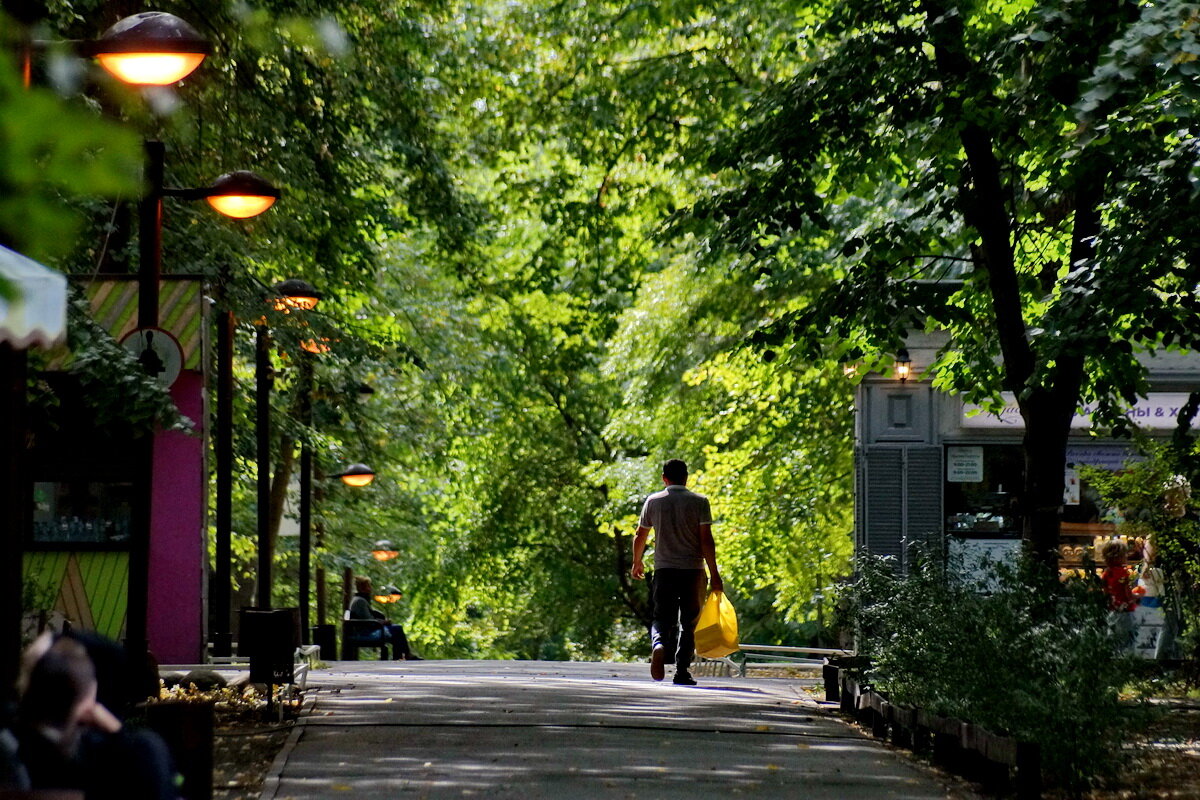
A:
0,245,67,350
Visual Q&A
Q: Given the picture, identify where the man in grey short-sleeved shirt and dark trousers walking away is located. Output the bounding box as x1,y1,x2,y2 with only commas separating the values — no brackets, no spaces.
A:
630,458,725,686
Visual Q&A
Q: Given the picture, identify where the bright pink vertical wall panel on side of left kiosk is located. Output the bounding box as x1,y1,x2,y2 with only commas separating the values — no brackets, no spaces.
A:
146,369,205,664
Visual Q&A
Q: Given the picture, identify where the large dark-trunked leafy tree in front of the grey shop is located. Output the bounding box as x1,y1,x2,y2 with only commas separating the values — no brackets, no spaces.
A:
696,0,1200,576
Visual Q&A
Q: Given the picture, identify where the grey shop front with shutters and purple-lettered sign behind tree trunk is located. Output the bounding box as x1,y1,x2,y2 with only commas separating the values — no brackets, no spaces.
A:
854,337,1200,571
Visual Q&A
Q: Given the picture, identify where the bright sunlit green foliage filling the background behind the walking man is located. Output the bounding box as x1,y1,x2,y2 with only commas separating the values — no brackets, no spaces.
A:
16,0,852,657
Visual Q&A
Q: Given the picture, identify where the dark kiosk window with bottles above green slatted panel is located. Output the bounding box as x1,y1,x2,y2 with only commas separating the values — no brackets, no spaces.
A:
34,480,133,545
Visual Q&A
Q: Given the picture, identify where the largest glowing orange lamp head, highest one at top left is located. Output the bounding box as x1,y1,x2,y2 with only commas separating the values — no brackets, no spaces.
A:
90,11,212,86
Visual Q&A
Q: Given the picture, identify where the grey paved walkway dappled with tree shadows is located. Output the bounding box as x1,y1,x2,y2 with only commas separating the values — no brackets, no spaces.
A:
263,661,967,800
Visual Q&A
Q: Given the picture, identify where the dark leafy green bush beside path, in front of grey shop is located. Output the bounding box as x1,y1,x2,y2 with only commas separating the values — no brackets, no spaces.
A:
845,557,1139,788
